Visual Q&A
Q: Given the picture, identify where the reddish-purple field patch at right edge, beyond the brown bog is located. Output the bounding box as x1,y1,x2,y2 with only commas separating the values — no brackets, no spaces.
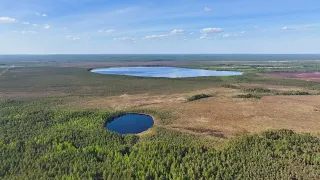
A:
269,72,320,82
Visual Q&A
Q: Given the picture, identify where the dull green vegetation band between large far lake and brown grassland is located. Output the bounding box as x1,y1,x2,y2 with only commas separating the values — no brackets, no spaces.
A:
0,67,320,99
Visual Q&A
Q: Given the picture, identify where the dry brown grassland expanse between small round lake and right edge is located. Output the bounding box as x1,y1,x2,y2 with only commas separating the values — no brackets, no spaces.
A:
62,87,320,137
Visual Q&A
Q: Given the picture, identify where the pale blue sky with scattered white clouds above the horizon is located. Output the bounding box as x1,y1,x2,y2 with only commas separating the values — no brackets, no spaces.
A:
0,0,320,54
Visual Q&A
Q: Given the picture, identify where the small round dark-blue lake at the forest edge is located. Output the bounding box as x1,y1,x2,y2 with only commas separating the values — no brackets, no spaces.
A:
106,114,154,134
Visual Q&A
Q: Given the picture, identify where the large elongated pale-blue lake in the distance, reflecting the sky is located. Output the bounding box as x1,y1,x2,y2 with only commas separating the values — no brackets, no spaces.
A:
91,67,243,78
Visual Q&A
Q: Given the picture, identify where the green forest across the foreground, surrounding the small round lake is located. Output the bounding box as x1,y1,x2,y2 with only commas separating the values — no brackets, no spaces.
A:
0,100,320,180
